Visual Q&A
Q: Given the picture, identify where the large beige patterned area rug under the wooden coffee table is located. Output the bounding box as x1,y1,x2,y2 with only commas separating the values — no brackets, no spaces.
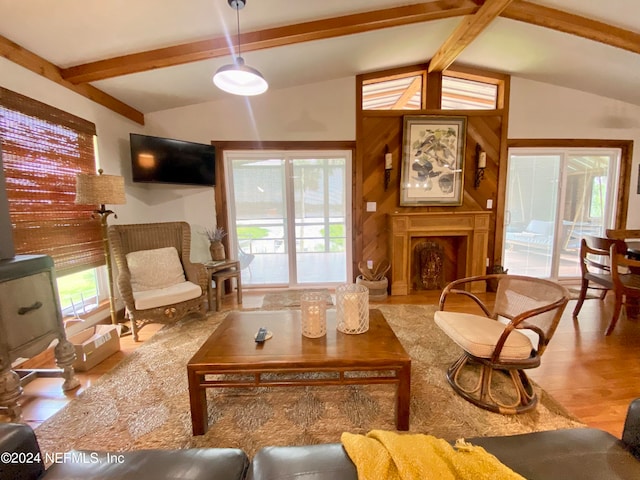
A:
36,305,583,456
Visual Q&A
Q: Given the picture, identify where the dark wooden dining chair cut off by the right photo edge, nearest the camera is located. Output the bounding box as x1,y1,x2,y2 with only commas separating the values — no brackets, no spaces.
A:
605,243,640,335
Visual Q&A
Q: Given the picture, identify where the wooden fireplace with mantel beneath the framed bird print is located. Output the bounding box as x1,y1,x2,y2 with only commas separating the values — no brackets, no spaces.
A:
389,212,491,295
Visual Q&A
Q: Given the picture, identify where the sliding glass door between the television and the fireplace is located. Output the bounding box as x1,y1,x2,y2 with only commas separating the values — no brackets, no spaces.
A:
225,151,351,287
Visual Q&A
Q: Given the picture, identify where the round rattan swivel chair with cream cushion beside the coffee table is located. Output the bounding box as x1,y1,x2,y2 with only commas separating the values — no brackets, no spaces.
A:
435,274,569,414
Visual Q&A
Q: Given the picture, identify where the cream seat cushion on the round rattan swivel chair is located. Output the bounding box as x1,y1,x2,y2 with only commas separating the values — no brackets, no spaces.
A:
434,311,533,360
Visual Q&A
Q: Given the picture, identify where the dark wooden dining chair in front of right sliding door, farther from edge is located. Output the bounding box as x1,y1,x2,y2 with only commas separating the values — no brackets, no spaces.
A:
573,236,625,318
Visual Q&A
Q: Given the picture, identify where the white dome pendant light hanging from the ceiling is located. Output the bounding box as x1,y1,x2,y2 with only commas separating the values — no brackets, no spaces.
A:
213,0,269,96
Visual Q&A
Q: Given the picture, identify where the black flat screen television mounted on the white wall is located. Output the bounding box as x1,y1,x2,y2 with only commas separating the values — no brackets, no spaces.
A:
129,133,216,186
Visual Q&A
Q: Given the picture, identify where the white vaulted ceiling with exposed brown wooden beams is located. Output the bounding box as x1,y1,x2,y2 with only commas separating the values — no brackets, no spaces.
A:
0,0,640,123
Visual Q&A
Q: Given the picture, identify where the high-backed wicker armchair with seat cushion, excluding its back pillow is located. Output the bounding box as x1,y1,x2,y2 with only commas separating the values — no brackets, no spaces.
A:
108,222,207,342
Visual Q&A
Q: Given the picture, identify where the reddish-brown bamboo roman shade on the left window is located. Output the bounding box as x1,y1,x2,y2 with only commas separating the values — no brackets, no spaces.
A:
0,87,105,274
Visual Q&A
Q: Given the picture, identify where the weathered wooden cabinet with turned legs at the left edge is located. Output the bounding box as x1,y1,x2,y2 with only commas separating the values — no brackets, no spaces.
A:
0,255,79,420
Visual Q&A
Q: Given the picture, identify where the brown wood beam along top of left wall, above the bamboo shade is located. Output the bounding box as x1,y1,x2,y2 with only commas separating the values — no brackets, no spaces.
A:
0,35,144,125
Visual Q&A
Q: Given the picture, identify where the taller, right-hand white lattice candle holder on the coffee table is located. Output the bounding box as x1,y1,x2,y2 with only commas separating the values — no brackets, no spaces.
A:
336,284,369,334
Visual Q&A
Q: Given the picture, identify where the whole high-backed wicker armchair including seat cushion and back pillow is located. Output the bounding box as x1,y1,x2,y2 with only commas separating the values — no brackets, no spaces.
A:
108,222,208,342
